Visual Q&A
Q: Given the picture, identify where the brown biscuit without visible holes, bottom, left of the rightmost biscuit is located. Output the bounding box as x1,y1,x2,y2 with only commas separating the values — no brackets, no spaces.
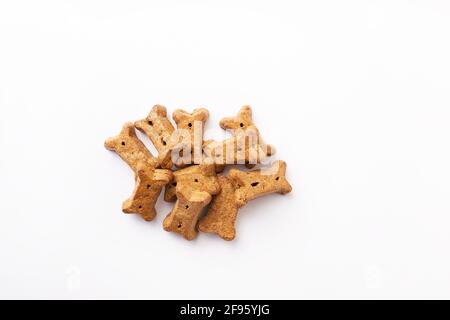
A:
198,176,239,241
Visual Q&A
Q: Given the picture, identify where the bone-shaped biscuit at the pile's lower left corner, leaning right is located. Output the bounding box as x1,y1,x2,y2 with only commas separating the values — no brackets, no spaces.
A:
122,166,172,221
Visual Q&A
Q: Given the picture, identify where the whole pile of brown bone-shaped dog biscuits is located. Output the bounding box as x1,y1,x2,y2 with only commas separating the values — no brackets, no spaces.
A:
105,105,292,240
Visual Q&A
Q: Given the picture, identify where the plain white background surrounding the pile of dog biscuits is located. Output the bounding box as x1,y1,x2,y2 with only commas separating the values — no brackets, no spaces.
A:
0,0,450,299
